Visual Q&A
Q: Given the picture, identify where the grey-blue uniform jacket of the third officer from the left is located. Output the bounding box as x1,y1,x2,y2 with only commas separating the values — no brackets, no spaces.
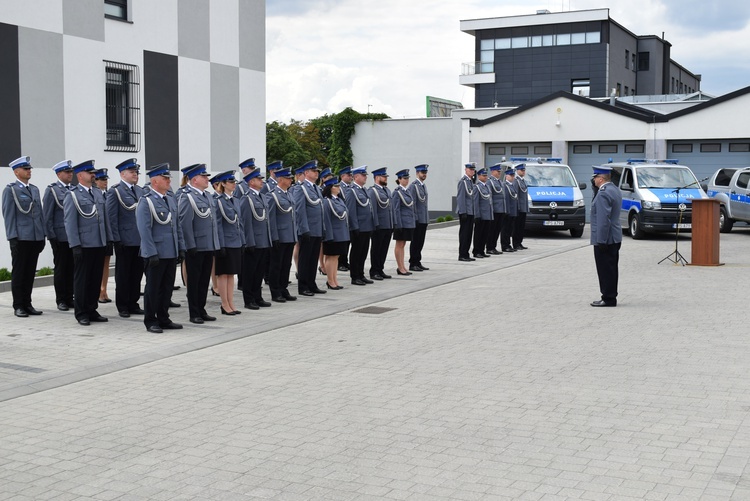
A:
63,184,112,248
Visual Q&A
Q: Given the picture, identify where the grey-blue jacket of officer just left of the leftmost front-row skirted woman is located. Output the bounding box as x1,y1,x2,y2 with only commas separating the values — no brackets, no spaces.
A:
177,188,220,252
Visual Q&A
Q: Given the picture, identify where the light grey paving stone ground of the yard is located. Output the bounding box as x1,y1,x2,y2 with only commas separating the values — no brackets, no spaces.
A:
0,226,750,500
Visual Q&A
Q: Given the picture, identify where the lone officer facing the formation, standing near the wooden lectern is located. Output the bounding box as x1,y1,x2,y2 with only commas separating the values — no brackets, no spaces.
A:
591,165,622,306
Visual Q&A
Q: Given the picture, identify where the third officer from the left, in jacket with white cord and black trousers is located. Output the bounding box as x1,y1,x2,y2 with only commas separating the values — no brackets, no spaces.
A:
63,160,112,325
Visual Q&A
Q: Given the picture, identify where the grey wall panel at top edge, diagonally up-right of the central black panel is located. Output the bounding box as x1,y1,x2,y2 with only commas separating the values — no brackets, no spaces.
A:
177,0,211,61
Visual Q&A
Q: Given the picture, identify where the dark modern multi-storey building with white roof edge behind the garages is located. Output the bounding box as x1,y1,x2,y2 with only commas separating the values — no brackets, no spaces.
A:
459,9,701,108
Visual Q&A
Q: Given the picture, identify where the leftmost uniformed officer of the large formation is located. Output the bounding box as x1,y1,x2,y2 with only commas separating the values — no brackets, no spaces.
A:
3,157,44,317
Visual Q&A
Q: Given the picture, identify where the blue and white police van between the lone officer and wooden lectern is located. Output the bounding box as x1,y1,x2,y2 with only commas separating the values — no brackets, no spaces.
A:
607,159,708,239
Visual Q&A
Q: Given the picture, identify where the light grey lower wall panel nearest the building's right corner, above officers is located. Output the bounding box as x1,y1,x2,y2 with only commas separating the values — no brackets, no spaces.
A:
209,63,241,173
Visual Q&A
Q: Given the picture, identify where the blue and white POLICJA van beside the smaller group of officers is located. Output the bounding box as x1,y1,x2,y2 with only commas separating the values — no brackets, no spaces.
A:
510,157,586,238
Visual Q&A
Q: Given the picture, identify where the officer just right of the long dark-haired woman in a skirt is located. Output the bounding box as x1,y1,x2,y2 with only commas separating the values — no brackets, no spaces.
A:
346,165,375,285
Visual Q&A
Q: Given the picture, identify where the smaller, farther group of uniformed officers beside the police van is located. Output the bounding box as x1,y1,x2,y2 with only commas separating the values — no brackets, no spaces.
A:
456,162,529,261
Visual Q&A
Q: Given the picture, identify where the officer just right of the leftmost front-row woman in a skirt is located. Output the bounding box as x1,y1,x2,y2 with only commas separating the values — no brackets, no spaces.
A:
240,169,271,310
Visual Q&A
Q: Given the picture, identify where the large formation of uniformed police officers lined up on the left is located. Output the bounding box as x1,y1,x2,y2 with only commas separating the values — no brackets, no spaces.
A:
2,156,429,333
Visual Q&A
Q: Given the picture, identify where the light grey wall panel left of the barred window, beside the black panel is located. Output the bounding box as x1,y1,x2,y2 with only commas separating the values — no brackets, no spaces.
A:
18,28,65,168
